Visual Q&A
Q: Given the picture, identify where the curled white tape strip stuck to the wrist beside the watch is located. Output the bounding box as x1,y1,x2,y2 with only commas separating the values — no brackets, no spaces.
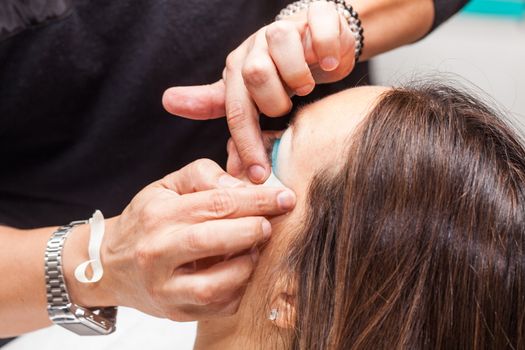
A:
75,210,105,283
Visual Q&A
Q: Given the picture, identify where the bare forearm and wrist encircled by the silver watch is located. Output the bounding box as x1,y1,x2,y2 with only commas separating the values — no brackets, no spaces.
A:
0,221,114,337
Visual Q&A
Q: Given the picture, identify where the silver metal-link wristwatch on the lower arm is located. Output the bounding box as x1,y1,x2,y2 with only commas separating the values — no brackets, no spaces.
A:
45,221,117,335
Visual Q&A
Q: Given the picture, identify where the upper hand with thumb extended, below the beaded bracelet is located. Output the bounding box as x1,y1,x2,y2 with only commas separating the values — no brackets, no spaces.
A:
163,1,355,183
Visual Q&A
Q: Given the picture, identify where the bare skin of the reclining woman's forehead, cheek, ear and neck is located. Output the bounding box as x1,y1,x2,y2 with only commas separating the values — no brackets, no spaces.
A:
195,87,388,350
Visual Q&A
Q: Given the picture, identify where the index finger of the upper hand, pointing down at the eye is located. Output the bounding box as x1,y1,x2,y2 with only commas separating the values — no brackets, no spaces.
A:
225,50,270,183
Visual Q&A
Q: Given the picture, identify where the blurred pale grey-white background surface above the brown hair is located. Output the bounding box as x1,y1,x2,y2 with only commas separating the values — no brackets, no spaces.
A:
365,14,525,124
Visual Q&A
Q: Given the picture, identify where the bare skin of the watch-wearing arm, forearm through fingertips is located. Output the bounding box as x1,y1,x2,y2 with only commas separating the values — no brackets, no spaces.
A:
0,160,295,337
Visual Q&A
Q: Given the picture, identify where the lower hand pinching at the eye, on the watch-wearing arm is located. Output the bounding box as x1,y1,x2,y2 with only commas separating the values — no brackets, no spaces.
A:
93,160,295,321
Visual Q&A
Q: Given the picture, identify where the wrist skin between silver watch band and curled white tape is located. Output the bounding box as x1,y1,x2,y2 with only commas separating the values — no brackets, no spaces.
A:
63,219,117,308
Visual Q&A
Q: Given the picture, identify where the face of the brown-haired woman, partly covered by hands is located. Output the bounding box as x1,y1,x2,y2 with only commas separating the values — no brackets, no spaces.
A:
199,87,387,348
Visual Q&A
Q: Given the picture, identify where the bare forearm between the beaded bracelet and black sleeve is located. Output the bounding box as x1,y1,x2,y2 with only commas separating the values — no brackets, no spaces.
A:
350,0,434,60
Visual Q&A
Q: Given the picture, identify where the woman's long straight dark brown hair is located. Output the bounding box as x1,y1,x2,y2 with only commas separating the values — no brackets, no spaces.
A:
287,83,525,350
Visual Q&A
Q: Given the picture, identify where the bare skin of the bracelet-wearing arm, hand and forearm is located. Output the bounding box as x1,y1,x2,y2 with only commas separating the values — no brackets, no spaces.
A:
163,0,434,183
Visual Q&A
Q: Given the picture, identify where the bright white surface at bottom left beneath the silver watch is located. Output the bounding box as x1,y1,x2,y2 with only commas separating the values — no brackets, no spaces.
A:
2,308,196,350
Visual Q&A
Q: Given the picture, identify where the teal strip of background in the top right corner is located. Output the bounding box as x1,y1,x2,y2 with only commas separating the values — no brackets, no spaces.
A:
463,0,525,19
